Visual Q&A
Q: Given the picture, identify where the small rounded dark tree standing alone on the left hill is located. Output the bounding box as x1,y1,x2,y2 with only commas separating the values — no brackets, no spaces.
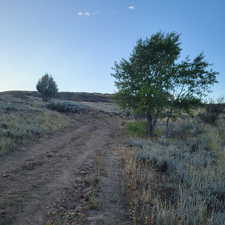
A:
36,74,58,102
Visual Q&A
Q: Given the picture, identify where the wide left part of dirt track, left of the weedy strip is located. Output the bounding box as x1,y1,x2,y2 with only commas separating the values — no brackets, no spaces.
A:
0,114,127,225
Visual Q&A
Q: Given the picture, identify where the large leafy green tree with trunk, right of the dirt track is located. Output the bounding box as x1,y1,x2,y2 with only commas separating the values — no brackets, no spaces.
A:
112,32,217,135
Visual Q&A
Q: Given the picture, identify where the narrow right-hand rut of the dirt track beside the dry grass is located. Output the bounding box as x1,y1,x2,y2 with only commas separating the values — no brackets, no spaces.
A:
91,144,130,225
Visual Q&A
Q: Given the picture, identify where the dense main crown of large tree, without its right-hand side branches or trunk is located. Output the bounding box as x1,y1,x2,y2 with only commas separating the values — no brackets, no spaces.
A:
113,33,180,113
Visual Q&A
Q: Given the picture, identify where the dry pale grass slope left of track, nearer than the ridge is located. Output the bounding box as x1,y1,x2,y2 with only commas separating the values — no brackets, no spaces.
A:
0,95,71,155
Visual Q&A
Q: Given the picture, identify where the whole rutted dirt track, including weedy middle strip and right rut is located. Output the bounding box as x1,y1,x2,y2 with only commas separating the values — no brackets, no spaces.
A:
0,112,127,225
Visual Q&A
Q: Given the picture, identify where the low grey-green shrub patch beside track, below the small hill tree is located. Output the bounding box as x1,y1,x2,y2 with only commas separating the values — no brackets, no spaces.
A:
47,101,88,113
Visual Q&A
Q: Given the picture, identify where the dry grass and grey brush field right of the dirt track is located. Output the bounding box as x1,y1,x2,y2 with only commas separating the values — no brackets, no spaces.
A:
121,114,225,225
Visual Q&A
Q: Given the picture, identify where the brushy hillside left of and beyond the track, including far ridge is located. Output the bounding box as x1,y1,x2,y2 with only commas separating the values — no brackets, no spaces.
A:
0,91,118,155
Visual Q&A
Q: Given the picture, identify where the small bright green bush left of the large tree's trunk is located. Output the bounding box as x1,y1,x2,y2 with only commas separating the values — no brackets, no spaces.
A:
127,121,147,137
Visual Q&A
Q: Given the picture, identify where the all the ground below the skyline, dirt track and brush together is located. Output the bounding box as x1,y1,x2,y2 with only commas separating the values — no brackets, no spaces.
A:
0,92,225,225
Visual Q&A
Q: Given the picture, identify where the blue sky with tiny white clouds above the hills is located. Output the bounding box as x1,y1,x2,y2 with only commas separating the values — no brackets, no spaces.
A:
0,0,225,96
